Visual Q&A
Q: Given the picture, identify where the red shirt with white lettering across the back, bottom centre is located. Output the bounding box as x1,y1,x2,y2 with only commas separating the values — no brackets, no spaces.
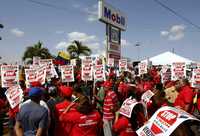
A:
63,110,101,136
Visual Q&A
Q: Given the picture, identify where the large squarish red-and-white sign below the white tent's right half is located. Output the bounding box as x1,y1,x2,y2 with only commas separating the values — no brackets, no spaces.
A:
171,62,186,80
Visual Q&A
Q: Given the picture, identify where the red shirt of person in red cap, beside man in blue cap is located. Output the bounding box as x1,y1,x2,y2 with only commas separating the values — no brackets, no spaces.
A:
55,100,73,136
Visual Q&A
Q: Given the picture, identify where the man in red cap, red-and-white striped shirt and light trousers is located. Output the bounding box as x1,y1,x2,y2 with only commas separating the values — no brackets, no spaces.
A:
103,81,119,136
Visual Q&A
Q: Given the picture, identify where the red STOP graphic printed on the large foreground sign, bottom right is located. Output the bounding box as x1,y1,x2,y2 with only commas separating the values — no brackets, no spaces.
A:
151,110,178,135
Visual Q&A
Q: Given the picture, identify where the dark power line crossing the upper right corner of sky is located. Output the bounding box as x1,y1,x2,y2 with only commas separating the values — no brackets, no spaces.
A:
153,0,200,30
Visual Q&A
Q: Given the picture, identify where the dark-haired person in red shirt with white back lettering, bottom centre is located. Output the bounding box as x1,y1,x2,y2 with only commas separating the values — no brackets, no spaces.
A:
61,96,102,136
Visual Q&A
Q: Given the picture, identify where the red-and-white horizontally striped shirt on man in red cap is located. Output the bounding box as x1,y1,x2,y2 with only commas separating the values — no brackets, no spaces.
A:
103,91,118,120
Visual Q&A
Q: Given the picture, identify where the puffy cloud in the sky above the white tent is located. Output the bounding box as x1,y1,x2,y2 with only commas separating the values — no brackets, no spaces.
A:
161,25,186,41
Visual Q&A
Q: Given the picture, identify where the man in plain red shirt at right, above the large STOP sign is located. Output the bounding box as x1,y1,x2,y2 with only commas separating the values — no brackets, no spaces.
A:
174,79,194,112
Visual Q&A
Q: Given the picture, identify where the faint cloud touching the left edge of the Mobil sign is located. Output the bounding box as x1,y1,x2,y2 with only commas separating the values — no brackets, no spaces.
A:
84,4,98,22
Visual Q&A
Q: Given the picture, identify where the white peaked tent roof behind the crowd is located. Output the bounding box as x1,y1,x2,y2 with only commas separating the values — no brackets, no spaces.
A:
141,51,194,65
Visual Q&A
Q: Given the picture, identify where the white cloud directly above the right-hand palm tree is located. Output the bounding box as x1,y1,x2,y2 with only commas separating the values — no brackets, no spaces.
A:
56,32,100,52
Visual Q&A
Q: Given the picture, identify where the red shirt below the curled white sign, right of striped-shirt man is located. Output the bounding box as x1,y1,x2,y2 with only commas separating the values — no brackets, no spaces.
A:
113,116,137,136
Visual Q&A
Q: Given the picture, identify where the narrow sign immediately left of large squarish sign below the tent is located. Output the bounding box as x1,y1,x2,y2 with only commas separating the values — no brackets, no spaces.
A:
161,65,171,83
